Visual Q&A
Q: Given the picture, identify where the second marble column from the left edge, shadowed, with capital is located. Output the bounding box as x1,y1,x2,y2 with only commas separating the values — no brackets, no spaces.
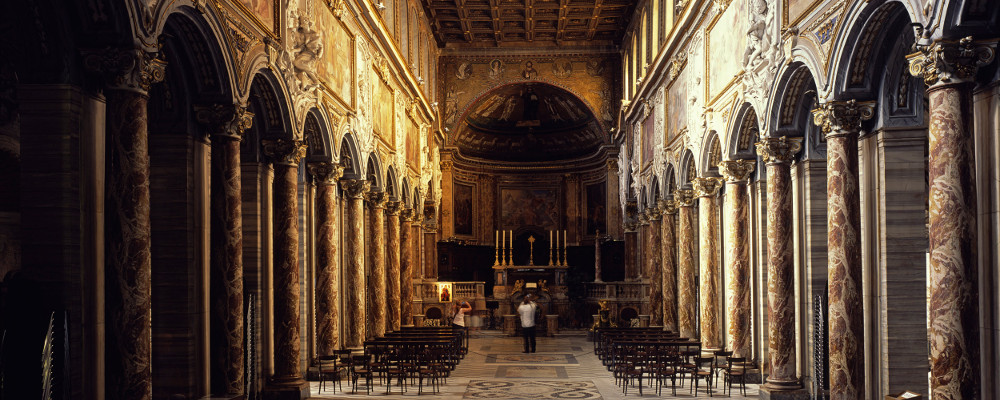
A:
195,104,253,396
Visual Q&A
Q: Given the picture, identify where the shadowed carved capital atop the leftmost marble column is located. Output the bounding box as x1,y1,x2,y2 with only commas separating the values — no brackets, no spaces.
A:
83,48,167,95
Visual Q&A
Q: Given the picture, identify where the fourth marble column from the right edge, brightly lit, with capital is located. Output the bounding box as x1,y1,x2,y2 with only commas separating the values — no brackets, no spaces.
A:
719,160,757,357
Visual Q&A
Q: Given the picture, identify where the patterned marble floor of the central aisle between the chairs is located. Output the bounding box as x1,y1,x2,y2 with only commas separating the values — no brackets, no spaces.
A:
311,332,758,400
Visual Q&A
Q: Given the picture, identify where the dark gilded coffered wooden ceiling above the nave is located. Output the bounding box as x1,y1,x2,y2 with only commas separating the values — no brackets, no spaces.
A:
421,0,637,47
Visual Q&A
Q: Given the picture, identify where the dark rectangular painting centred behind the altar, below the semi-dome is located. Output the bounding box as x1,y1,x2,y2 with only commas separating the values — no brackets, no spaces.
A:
500,188,559,230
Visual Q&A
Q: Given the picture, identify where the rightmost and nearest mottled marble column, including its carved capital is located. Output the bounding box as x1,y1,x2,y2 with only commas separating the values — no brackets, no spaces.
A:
908,37,996,400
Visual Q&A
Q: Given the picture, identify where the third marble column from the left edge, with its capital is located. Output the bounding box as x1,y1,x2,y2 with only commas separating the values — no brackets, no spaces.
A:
261,139,306,387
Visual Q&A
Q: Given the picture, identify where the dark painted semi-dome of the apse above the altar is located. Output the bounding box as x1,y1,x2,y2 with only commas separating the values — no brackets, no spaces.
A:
455,82,604,162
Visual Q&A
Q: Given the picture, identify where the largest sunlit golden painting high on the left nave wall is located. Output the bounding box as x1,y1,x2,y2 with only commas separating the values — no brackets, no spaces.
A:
313,1,354,106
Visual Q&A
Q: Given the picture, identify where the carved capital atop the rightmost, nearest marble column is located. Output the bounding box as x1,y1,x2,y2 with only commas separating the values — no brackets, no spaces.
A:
906,36,995,87
